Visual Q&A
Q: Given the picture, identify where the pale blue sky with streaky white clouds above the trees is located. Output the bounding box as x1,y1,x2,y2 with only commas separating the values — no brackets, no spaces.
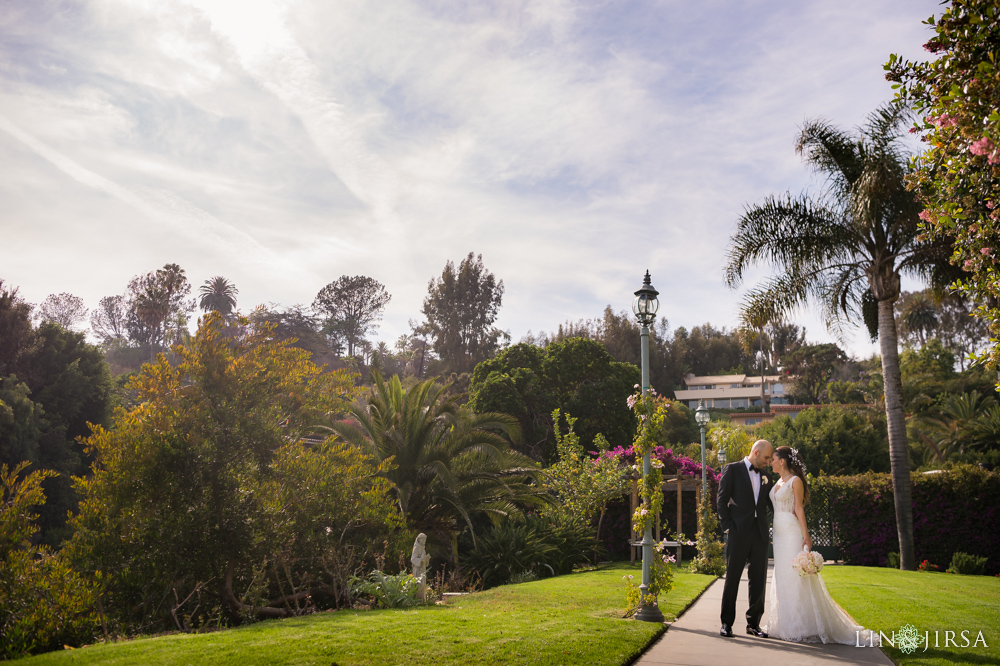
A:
0,0,940,355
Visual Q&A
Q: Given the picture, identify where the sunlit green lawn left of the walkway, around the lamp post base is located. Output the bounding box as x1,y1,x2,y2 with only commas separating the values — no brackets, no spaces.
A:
15,563,714,666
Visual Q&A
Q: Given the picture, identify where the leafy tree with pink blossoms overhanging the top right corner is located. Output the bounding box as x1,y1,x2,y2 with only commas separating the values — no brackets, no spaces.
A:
885,0,1000,365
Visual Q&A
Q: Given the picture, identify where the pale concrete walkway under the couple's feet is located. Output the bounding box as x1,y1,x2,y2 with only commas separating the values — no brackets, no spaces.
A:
635,563,892,666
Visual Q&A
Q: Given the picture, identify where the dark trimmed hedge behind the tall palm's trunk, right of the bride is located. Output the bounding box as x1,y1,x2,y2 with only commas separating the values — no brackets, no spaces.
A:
807,466,1000,575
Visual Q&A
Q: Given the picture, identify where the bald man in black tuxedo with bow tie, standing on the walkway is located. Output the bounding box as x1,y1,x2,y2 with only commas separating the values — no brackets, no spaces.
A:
718,439,774,638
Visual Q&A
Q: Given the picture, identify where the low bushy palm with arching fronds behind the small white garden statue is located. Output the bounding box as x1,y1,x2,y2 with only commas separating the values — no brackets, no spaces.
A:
329,373,547,559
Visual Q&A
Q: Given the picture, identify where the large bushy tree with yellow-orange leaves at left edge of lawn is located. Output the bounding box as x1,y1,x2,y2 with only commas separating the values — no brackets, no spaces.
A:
66,313,400,632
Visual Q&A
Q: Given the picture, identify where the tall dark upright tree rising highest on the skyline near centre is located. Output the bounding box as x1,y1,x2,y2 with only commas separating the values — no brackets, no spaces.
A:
417,252,510,372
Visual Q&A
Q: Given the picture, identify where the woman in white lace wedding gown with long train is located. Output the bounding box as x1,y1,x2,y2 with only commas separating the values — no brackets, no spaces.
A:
764,446,868,645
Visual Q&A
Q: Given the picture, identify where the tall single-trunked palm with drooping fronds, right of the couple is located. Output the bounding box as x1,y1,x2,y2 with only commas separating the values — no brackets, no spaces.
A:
725,105,951,569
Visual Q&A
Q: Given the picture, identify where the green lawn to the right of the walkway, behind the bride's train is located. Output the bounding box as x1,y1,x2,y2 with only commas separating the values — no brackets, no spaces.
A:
823,566,1000,666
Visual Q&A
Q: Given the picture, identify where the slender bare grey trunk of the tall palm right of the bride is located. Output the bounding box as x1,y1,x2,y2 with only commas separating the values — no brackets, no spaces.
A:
878,299,917,571
